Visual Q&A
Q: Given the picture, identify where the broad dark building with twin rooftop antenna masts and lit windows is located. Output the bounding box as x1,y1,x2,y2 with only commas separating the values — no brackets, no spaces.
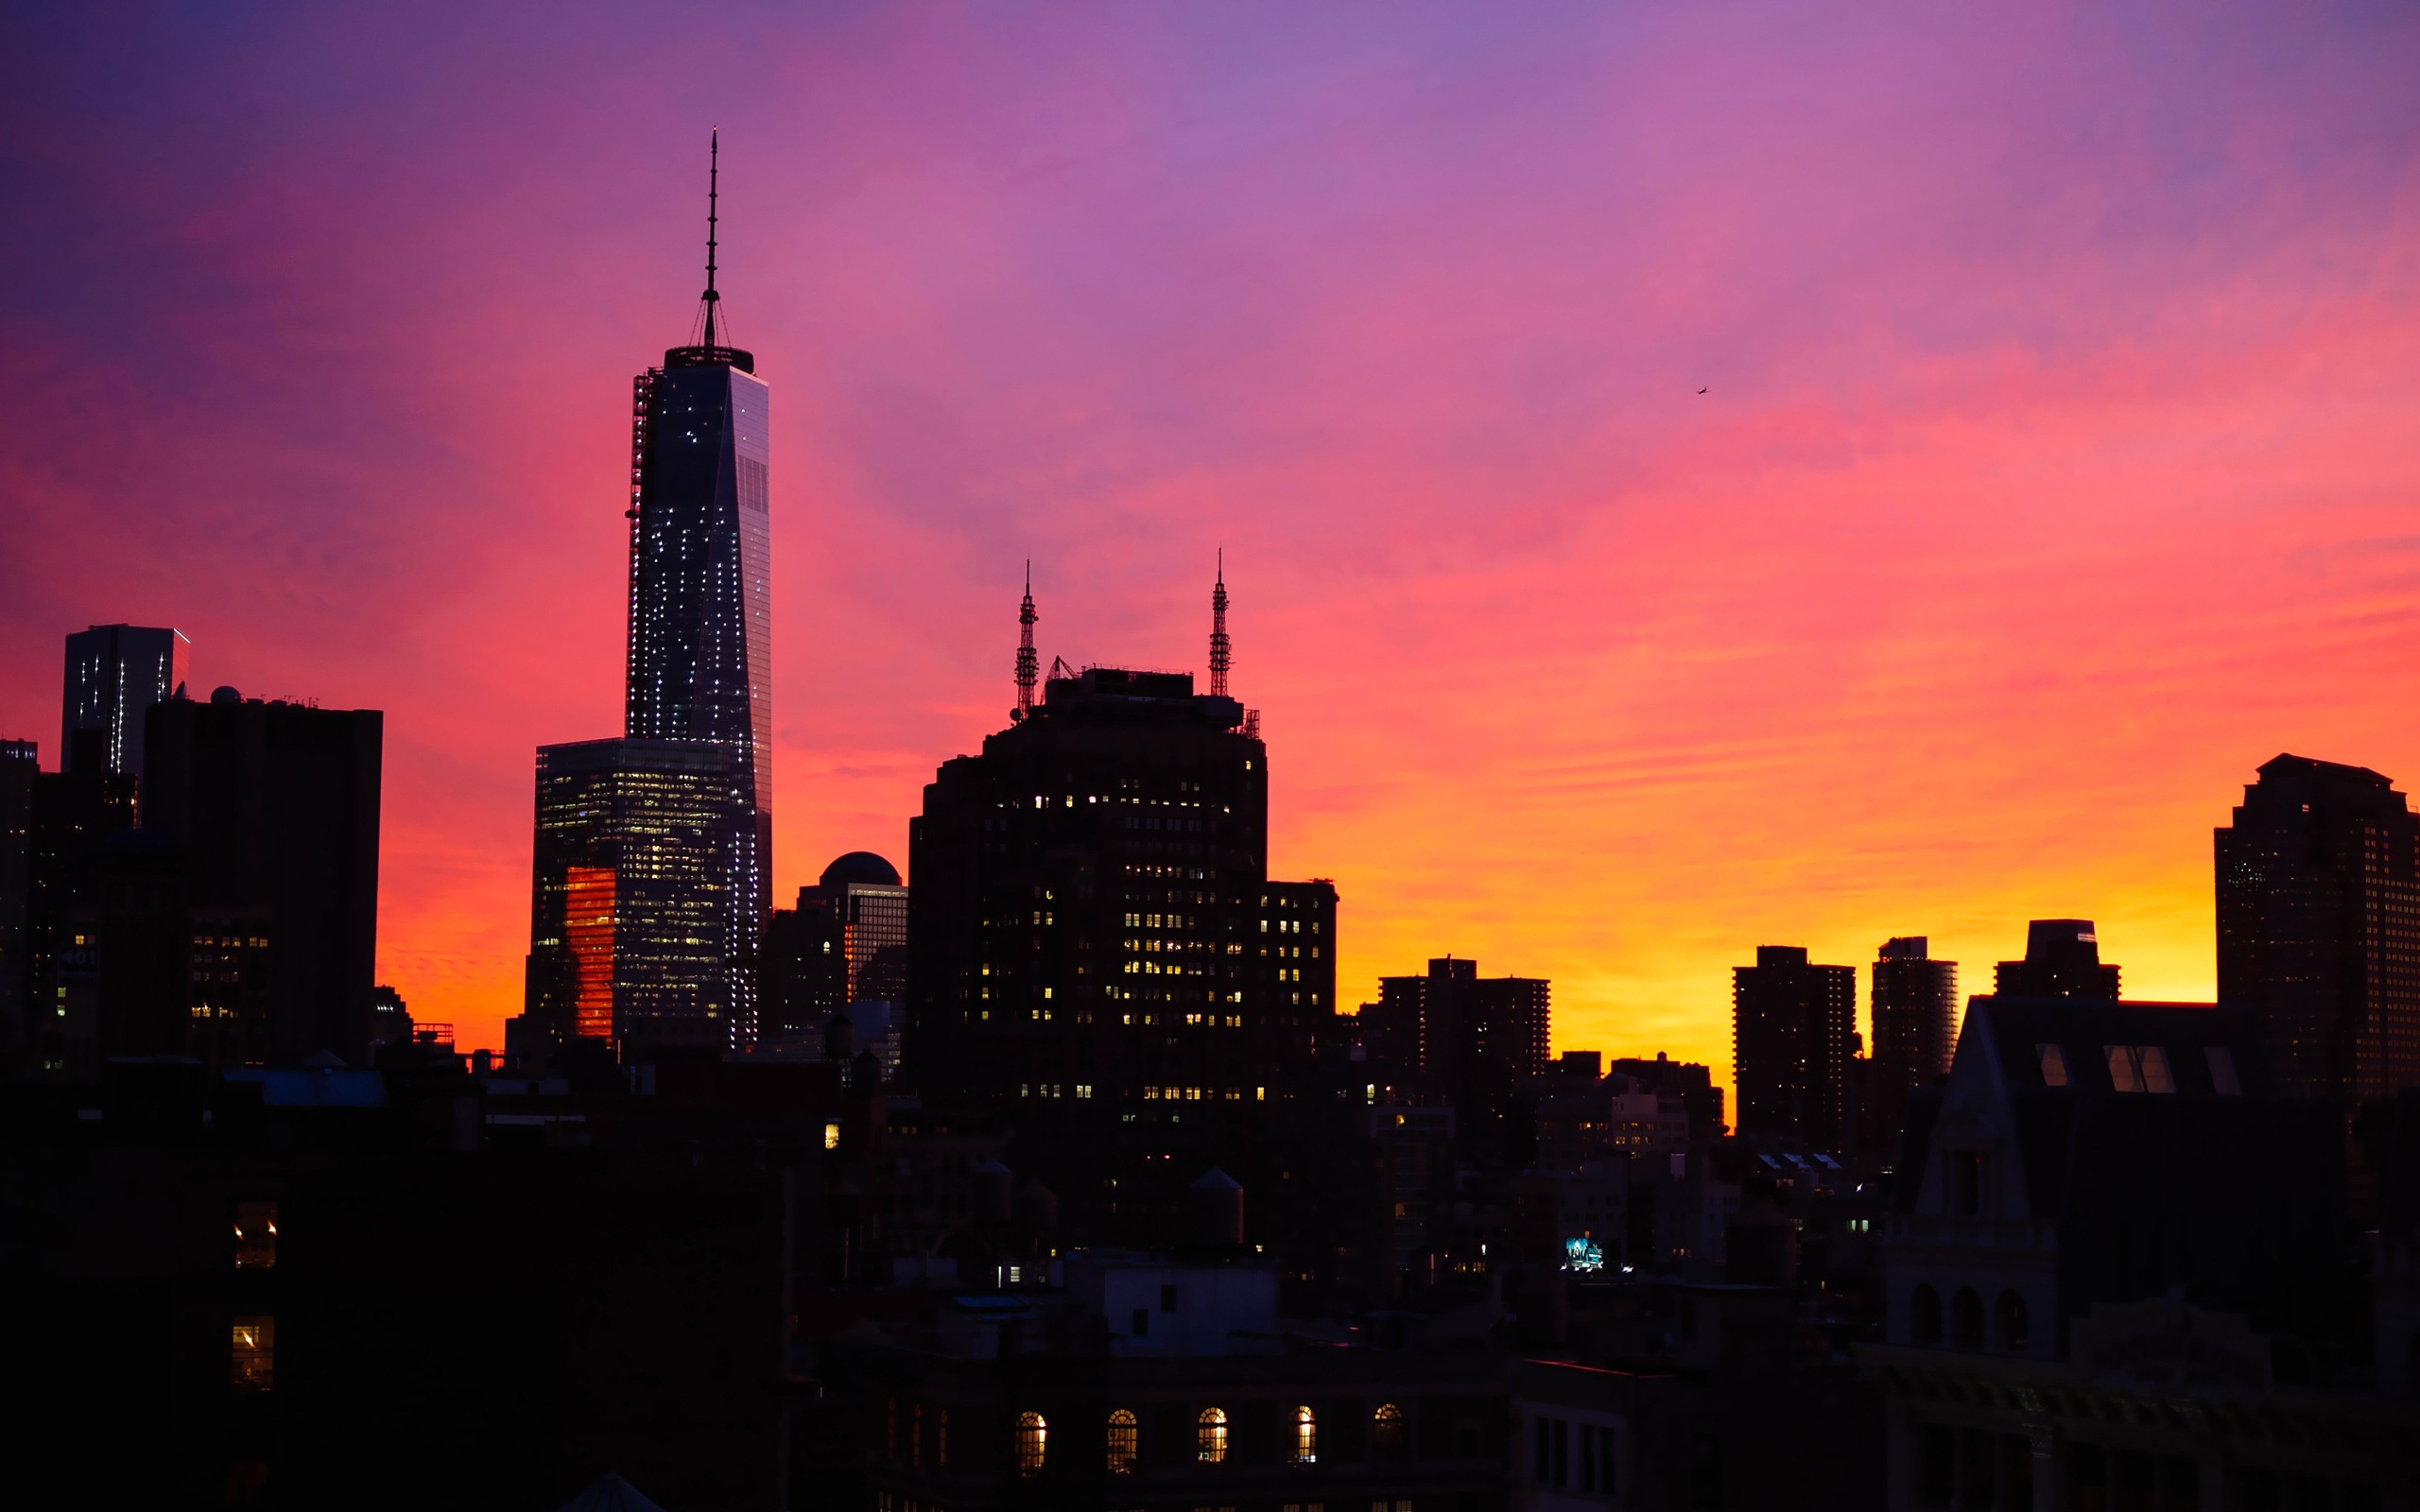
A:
908,571,1336,1239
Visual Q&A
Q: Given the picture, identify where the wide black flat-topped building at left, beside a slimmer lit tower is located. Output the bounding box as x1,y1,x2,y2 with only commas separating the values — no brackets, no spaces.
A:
139,687,385,1064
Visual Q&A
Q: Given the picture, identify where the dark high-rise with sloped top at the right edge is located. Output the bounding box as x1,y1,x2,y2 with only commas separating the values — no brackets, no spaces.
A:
2214,755,2420,1110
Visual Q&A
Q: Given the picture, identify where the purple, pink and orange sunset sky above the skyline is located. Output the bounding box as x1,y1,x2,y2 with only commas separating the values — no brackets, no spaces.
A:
0,0,2420,1081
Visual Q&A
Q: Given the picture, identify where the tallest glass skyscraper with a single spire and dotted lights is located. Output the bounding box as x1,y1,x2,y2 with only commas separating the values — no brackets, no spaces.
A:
624,132,772,1025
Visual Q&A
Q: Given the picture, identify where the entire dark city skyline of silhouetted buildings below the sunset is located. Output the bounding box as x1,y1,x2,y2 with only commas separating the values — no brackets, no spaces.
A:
0,159,2420,1512
